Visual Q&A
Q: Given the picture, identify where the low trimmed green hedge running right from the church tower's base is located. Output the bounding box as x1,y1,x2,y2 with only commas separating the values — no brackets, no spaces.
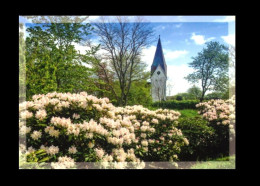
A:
152,100,199,110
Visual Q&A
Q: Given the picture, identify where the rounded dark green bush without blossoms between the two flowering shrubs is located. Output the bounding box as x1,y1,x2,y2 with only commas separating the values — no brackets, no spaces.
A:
176,117,215,161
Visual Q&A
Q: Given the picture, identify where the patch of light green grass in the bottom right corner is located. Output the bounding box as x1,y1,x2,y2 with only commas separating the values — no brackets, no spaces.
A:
191,155,235,169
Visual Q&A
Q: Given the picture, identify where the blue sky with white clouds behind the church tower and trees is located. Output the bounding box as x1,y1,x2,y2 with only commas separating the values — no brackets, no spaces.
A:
20,16,235,95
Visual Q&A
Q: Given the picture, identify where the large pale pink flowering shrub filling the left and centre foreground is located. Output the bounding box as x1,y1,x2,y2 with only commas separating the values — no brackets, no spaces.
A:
19,92,188,168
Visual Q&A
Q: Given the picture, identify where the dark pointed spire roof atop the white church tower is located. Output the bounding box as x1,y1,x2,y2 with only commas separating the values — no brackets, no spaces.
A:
151,36,167,76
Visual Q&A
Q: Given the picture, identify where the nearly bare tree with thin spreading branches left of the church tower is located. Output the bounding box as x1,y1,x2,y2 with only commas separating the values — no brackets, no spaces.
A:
94,16,152,106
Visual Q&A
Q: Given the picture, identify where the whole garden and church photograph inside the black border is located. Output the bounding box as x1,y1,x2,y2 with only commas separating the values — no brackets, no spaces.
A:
17,15,236,171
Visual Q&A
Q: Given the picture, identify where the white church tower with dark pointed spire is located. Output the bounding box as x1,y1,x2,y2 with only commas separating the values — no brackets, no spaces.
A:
151,35,167,101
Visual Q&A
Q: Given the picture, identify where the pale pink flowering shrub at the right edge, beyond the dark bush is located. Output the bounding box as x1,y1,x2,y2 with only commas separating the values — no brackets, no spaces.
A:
196,96,235,155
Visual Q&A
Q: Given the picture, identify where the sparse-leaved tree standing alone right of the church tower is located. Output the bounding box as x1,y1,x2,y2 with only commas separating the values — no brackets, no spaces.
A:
186,41,229,101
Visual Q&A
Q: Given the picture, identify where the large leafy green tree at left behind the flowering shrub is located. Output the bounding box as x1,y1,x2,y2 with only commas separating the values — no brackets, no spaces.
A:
23,16,102,98
